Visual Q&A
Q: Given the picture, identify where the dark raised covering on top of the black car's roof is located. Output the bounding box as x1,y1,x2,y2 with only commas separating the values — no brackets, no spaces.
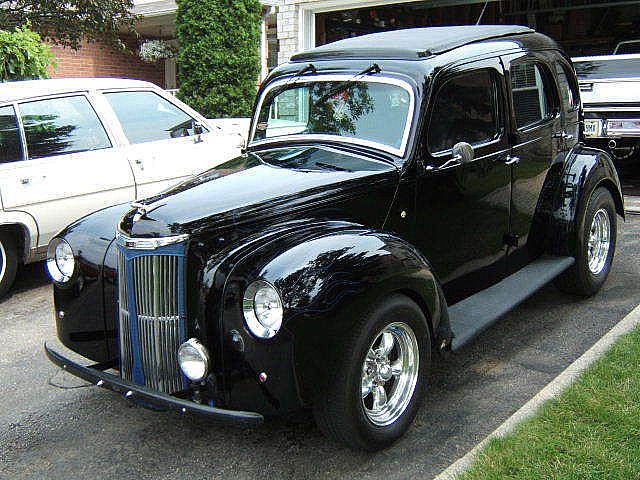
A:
291,25,542,62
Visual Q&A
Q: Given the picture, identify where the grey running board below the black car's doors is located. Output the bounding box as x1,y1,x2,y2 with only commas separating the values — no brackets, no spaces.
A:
449,255,575,350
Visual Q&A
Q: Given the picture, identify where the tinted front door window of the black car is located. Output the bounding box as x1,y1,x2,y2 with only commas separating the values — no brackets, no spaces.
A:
428,70,501,153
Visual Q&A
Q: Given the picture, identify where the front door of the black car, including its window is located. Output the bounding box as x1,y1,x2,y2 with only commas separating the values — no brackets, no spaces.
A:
413,58,511,303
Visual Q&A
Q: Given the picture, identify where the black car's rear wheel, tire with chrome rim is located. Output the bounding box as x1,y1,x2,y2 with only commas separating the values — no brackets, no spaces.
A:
555,187,618,297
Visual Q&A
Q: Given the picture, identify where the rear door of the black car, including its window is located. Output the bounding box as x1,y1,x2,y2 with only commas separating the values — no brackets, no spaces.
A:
502,53,565,273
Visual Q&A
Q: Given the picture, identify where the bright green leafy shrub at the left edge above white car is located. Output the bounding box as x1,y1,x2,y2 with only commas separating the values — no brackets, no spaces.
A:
0,27,54,82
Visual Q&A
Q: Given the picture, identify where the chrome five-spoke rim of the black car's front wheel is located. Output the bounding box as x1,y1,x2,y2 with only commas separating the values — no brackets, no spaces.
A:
361,322,420,426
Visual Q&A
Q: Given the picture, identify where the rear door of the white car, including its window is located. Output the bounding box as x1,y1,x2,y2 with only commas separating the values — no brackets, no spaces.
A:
0,93,134,246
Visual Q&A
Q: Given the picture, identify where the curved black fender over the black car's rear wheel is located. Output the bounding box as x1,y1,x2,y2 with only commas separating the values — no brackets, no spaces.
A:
551,144,625,256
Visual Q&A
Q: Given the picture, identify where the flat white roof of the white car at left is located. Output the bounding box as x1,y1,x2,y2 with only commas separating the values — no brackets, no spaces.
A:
0,78,158,102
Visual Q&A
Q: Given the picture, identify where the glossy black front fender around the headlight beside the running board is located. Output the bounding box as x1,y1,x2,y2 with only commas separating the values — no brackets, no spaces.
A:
215,224,448,410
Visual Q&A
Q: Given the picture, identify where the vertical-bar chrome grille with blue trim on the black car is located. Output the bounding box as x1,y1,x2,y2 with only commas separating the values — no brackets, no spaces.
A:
118,252,183,393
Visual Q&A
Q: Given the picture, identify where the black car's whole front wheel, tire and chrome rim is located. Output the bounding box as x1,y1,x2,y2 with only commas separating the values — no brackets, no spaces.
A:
314,295,431,451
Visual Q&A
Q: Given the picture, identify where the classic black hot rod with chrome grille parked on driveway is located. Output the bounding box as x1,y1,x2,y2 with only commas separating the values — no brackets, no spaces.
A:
46,26,623,450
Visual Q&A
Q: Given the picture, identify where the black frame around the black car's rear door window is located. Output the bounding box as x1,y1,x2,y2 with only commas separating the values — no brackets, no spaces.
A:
507,55,562,133
